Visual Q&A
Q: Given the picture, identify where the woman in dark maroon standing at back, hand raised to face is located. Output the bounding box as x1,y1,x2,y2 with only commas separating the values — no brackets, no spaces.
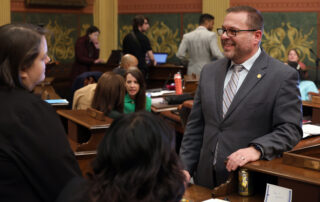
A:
71,26,103,79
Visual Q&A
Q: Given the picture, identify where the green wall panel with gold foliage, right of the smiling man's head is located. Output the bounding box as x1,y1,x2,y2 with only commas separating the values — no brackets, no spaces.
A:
262,13,317,66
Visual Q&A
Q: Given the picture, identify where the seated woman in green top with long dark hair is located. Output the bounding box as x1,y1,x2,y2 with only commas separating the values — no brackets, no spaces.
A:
124,67,151,114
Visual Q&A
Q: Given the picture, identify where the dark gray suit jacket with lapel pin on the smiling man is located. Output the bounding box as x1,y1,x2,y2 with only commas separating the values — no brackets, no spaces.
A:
180,51,302,188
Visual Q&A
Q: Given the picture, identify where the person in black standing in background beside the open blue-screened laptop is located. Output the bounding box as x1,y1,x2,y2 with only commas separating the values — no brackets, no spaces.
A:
123,15,157,78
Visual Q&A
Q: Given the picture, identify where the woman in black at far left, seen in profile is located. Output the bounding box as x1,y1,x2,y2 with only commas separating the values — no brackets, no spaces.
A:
0,24,81,202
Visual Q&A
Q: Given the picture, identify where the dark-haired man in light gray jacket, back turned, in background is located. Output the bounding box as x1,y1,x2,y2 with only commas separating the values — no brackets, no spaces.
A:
176,14,223,75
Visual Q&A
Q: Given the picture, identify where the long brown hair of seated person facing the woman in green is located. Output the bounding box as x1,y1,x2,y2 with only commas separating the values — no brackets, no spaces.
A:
91,72,126,119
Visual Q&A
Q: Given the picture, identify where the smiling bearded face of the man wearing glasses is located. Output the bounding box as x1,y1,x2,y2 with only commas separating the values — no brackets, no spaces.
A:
221,12,262,64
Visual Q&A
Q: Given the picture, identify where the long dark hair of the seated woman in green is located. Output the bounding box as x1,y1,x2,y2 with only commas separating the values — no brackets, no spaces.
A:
124,67,146,112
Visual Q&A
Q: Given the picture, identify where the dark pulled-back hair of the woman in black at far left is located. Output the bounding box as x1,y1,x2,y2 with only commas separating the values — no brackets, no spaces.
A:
0,24,44,88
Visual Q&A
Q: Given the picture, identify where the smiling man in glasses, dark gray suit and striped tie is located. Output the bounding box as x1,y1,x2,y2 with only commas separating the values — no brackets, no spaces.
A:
180,6,302,188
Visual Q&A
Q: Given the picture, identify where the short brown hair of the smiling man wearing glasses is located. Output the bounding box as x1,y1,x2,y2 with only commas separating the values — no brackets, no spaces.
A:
227,6,264,32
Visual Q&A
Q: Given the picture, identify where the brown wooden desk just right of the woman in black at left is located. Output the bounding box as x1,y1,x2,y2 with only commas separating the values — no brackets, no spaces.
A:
57,110,112,152
